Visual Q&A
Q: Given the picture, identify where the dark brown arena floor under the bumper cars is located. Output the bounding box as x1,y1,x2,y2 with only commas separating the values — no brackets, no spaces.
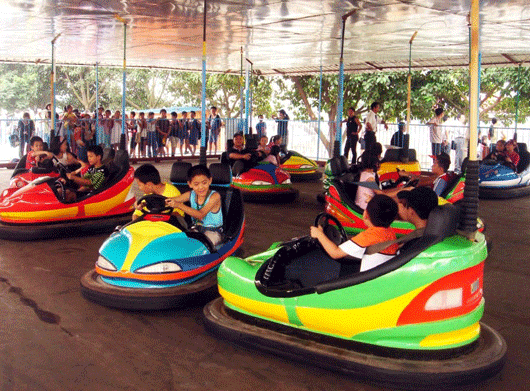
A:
0,163,530,391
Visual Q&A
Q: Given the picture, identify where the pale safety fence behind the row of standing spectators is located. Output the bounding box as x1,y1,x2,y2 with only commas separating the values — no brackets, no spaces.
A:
0,118,530,170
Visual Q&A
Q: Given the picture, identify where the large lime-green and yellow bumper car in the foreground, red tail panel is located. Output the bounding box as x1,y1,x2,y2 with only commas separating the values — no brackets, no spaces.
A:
203,205,506,389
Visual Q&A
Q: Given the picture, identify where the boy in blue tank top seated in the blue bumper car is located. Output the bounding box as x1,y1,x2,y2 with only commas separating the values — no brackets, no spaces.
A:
166,164,223,246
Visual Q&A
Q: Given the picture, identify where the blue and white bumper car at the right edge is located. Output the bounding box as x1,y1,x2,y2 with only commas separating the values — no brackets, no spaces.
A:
479,143,530,198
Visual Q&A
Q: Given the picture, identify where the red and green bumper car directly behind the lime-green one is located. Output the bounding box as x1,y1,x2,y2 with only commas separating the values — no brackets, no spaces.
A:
324,156,474,234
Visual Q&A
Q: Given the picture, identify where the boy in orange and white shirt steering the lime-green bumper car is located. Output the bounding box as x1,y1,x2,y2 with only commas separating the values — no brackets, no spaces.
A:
311,194,398,272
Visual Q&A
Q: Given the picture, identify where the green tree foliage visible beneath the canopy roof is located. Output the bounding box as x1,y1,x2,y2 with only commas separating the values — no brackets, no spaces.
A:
0,64,530,125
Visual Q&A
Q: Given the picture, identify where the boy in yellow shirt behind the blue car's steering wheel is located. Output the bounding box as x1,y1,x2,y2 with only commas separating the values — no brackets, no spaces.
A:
132,164,186,222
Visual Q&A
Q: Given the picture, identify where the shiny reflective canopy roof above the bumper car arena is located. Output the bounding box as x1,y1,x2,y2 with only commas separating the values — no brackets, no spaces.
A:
0,0,530,75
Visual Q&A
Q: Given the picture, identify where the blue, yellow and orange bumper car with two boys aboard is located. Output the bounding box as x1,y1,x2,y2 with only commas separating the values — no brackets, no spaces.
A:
81,163,244,310
